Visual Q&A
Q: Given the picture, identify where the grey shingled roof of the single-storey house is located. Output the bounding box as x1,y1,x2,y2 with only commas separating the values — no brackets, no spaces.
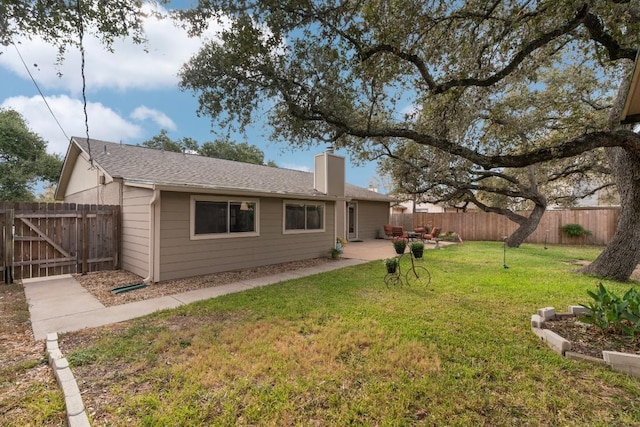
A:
67,137,393,201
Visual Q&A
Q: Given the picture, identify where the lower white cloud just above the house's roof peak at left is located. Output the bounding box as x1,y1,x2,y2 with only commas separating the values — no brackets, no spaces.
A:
0,95,144,155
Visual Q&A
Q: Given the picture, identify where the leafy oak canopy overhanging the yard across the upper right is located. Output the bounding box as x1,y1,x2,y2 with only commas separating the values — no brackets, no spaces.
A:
179,0,640,164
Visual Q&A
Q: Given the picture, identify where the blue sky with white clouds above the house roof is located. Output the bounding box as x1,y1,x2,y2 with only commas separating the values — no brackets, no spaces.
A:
0,4,382,191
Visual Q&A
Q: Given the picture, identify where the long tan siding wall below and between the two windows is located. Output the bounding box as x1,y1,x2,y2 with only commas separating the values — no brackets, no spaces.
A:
156,192,334,280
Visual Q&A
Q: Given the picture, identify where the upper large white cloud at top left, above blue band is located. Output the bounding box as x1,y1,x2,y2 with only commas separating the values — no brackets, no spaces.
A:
0,4,229,95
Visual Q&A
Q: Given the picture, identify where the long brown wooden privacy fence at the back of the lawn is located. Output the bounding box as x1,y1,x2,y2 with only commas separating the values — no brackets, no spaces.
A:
391,208,620,245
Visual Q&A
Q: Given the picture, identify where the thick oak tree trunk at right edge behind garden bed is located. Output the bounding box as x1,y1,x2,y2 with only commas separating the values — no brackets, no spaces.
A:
582,148,640,281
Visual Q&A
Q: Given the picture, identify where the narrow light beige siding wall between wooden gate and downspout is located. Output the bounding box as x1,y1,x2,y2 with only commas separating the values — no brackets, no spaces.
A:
122,186,153,277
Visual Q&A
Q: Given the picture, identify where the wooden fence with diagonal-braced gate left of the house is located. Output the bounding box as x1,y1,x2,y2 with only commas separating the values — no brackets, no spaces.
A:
0,202,120,283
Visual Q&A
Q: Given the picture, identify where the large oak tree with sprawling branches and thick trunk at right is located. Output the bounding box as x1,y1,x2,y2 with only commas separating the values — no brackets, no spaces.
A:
181,0,640,280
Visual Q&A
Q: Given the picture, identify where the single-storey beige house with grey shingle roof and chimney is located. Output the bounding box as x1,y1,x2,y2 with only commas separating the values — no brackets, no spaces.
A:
56,137,393,281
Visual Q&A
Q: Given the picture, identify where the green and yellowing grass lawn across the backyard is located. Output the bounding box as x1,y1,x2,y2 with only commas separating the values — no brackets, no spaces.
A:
61,243,640,426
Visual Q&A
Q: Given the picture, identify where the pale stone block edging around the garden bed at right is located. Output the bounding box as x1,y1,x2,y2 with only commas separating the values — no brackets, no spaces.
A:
531,305,640,378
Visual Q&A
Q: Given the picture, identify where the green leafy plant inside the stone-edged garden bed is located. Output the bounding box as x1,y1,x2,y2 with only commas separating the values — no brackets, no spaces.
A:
580,283,640,336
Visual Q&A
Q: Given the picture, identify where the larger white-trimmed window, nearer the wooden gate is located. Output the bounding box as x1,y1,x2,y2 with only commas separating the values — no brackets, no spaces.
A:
191,196,258,239
